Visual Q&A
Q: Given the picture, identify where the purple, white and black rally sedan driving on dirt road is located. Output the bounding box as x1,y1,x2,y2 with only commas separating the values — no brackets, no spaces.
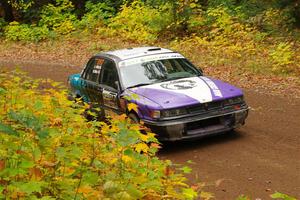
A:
68,47,248,140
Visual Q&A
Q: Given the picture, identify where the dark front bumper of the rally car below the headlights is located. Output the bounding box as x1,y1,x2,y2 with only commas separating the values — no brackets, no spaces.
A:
144,105,249,141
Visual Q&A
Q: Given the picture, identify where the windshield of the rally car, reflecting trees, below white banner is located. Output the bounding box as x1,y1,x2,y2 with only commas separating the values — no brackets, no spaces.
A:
120,58,201,88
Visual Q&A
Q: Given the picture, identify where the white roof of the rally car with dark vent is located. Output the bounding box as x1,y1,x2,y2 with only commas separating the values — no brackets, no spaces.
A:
97,46,174,61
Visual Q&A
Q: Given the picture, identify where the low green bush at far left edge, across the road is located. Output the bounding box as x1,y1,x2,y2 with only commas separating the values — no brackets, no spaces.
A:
4,22,49,42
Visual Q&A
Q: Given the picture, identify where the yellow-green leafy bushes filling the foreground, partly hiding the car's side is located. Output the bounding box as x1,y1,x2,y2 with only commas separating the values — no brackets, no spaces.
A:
0,69,197,199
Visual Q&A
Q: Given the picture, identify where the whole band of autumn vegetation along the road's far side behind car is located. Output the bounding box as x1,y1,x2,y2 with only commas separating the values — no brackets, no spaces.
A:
0,0,300,76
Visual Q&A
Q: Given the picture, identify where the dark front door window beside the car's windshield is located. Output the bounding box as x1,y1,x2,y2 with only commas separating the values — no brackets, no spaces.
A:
100,60,119,89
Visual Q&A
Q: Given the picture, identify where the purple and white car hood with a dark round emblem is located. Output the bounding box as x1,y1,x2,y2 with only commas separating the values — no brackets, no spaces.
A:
130,76,243,109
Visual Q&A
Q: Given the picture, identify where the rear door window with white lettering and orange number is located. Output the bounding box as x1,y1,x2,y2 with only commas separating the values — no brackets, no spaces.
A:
83,58,104,82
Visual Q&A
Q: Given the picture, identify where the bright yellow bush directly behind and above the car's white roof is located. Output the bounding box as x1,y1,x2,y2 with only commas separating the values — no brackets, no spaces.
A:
109,1,171,41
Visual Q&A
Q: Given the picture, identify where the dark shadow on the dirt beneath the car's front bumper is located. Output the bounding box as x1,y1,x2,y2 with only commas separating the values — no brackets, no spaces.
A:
158,130,245,156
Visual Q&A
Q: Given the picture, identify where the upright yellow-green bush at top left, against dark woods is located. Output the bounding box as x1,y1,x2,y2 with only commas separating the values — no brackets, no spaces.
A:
39,0,77,35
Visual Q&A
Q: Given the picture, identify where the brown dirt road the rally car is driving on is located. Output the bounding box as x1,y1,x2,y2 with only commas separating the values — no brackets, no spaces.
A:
0,63,300,200
